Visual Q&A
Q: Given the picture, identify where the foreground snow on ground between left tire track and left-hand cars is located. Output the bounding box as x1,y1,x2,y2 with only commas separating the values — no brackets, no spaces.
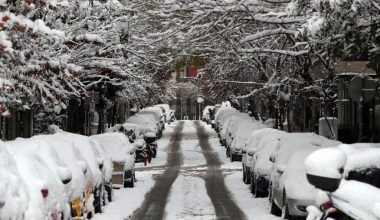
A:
93,171,160,220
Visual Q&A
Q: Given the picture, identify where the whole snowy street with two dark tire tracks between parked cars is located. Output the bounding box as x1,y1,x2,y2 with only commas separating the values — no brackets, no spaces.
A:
95,121,279,220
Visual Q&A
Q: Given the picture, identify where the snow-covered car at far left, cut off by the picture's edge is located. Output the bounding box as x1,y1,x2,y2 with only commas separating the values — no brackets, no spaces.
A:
0,142,29,220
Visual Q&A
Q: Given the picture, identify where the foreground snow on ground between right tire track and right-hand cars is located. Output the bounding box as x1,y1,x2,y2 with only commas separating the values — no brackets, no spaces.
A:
225,172,281,220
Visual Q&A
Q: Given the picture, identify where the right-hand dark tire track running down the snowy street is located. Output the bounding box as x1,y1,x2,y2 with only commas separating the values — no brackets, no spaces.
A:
194,121,247,220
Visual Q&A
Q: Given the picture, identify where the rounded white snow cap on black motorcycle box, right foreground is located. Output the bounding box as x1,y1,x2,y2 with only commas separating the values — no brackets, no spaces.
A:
305,148,347,179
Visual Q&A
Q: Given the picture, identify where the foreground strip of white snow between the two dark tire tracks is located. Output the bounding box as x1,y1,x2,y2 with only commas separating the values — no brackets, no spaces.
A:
165,175,215,220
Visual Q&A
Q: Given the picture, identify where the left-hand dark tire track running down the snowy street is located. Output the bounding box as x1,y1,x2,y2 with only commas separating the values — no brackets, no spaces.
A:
131,122,184,220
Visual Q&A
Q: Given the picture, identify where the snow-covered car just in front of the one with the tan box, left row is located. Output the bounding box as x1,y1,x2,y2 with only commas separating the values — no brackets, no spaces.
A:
57,133,105,213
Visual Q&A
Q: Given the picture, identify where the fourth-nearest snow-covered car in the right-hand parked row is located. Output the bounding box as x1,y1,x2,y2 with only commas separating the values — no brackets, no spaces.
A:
226,118,265,162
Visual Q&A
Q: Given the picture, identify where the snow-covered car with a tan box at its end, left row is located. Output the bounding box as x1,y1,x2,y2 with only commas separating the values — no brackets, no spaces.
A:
91,133,135,188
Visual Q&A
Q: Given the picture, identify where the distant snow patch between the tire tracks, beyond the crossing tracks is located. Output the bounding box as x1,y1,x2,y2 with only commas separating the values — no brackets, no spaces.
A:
181,139,207,167
